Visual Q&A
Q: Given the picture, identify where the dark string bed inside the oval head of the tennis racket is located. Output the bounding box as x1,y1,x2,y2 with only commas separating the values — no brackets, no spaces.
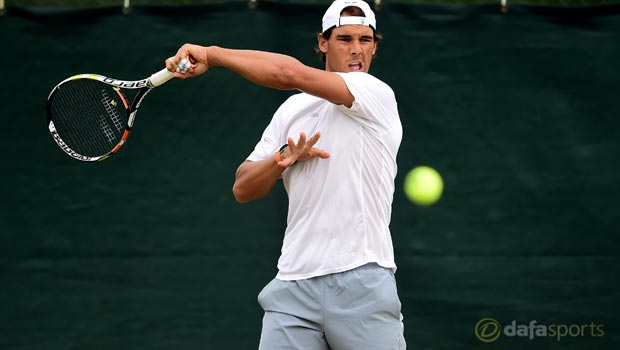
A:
48,78,128,157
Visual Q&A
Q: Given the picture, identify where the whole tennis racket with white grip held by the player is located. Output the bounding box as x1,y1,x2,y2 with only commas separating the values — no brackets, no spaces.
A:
45,60,189,162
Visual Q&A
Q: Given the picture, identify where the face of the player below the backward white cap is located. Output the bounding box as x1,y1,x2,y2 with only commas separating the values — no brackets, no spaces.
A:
319,25,377,73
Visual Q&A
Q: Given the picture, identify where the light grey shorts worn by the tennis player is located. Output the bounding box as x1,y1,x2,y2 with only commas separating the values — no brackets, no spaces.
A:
258,264,406,350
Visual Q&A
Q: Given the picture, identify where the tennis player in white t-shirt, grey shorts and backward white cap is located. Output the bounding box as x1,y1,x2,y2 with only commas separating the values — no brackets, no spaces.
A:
166,0,406,350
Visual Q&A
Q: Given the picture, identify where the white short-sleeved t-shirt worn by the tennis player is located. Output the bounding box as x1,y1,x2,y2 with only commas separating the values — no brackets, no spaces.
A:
248,72,402,280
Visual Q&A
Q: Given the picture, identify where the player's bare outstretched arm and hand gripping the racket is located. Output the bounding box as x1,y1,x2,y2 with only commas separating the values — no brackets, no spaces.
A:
166,44,354,107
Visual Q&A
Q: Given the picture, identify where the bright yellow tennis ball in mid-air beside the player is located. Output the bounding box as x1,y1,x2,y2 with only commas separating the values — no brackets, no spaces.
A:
405,166,443,205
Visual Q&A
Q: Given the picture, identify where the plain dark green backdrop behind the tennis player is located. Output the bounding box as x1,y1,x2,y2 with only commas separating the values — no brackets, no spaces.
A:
0,4,620,350
